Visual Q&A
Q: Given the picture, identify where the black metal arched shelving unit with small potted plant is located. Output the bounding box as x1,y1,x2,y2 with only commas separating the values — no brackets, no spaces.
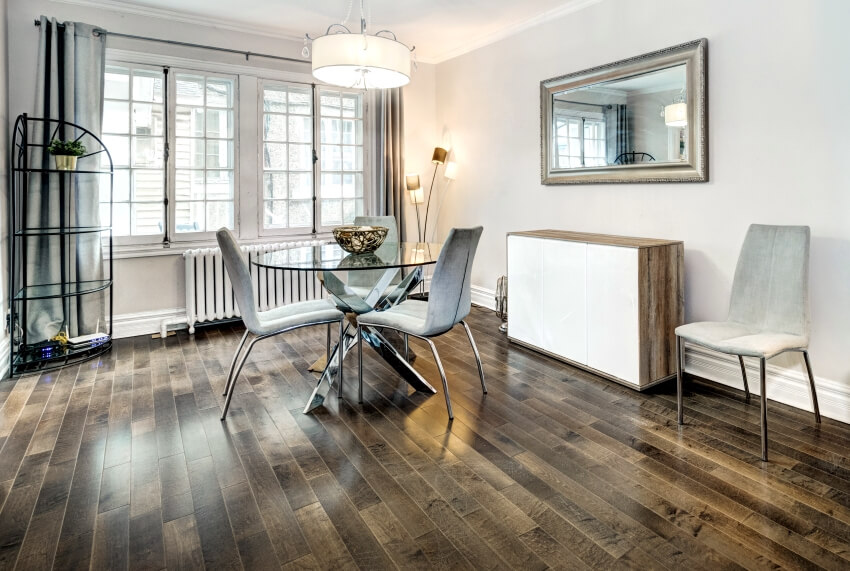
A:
7,114,113,376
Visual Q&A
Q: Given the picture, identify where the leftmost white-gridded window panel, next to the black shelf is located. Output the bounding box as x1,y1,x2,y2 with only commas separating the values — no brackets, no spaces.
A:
101,66,165,236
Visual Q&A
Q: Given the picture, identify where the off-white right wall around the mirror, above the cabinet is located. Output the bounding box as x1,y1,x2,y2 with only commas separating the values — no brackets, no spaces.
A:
436,0,850,394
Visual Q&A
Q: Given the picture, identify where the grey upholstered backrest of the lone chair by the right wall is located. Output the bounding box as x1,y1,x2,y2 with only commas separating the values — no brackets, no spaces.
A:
729,224,811,337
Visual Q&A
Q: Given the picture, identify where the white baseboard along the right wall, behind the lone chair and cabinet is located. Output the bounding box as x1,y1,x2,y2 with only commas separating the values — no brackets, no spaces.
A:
471,285,850,423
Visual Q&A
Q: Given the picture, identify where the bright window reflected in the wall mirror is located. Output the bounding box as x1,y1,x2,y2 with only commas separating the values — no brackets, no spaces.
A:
555,113,608,168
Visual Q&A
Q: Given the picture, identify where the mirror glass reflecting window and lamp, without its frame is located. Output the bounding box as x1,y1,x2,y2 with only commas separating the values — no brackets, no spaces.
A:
550,63,688,169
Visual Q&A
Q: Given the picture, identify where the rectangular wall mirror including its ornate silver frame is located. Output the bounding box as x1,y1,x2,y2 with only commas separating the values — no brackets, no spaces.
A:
540,39,708,184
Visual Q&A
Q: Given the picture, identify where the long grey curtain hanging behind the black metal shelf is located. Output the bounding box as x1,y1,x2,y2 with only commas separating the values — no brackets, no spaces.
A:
24,16,108,343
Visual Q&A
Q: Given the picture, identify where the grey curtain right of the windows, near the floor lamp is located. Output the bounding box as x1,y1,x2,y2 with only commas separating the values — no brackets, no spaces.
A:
372,88,407,241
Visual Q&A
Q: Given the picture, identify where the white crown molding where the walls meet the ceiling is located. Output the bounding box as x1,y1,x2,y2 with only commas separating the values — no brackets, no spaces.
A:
52,0,602,65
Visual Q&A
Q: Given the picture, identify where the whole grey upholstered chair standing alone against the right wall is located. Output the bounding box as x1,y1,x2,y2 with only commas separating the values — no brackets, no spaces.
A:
676,224,821,462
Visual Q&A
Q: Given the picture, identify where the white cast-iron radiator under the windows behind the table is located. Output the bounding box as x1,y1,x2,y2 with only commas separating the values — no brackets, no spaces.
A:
183,240,328,333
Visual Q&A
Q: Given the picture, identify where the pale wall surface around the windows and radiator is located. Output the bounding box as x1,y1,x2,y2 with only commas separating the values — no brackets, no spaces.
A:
8,0,435,322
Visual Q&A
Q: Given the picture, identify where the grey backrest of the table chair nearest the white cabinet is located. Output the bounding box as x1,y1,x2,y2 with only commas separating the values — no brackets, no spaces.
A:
425,226,484,336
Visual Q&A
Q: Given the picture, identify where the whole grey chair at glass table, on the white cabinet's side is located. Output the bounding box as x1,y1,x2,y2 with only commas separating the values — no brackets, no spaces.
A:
357,226,487,419
